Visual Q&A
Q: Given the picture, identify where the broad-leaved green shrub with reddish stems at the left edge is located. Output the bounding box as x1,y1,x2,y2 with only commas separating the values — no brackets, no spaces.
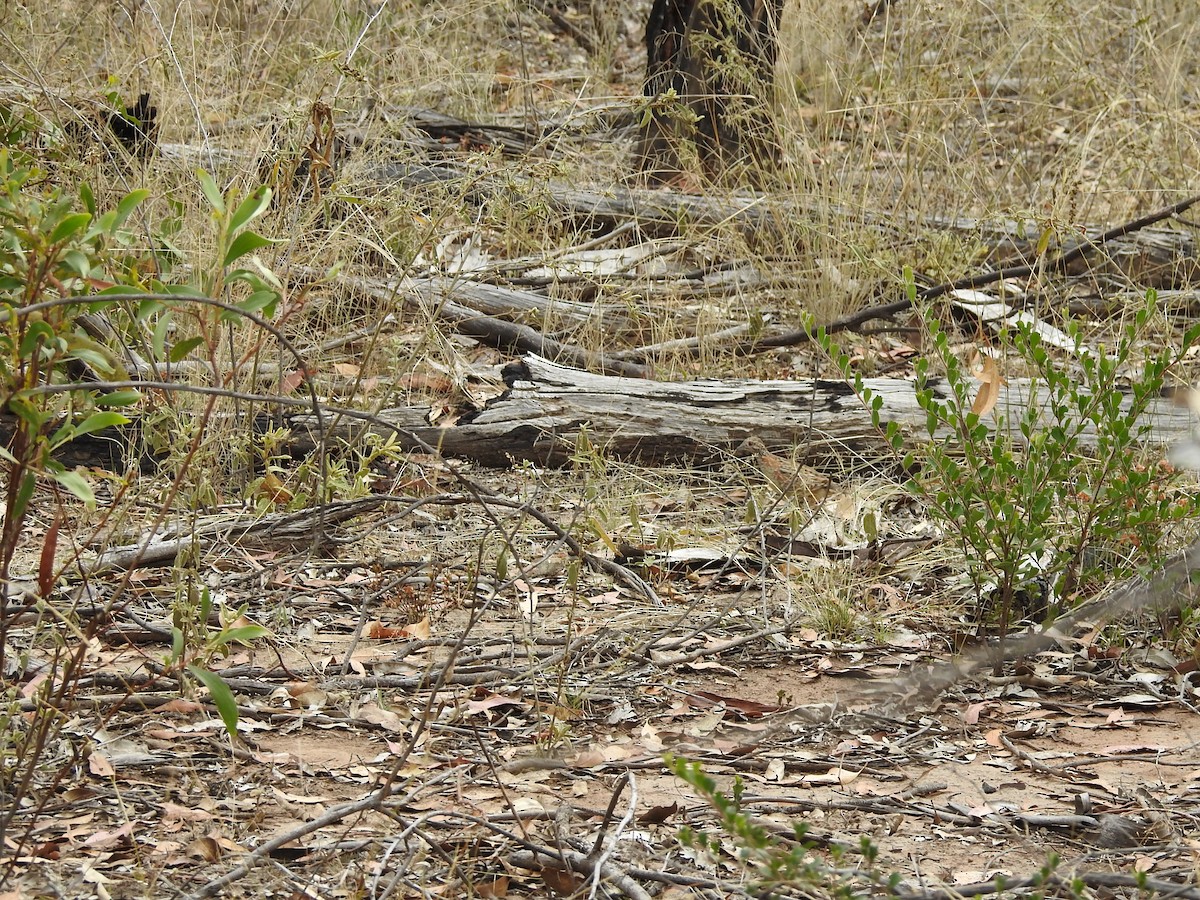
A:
0,146,280,868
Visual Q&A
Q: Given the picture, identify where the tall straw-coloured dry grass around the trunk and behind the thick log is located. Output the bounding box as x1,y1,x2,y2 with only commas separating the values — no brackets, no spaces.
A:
0,0,1200,633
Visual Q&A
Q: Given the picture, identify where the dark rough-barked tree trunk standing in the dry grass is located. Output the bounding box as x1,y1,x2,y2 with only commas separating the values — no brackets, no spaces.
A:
638,0,784,182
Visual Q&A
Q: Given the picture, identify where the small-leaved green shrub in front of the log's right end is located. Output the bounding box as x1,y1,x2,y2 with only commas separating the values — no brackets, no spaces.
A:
816,276,1200,666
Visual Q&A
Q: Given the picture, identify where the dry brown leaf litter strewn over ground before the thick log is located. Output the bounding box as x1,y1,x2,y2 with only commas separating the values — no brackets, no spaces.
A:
6,3,1200,898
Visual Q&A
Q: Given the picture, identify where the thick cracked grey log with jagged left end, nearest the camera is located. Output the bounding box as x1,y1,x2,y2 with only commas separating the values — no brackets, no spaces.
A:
274,355,1193,472
